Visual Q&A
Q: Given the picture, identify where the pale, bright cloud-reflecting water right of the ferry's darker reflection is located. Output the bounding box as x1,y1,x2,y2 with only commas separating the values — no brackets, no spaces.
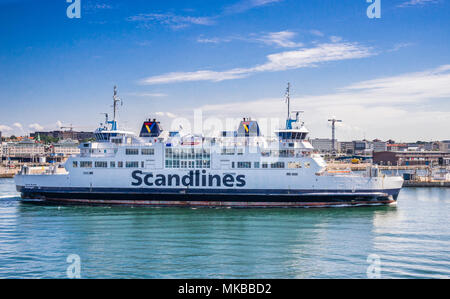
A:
374,188,450,278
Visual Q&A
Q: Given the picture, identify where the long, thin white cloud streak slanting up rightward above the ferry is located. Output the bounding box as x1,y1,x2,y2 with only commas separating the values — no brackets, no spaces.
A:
142,43,374,85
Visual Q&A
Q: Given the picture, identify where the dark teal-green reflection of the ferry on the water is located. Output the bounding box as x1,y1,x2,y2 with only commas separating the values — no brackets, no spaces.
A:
6,204,396,278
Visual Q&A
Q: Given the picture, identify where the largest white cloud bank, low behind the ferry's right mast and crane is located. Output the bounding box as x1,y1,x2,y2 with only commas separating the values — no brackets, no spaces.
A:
180,65,450,141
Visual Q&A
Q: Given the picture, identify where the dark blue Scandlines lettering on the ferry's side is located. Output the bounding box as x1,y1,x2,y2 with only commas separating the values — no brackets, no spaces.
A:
131,170,247,188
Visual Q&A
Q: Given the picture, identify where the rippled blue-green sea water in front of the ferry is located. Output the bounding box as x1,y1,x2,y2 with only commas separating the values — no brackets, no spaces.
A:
0,180,450,278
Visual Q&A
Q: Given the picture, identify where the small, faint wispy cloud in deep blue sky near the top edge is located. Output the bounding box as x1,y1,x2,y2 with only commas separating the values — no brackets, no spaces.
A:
127,13,215,29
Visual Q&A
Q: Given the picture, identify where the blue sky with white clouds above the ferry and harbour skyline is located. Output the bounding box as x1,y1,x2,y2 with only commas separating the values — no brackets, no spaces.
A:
0,0,450,141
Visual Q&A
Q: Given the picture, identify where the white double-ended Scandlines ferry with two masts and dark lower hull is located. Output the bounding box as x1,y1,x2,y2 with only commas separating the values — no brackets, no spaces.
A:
15,88,403,208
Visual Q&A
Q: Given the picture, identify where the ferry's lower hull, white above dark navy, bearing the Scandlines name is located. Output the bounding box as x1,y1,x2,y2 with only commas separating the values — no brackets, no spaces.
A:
15,169,403,207
